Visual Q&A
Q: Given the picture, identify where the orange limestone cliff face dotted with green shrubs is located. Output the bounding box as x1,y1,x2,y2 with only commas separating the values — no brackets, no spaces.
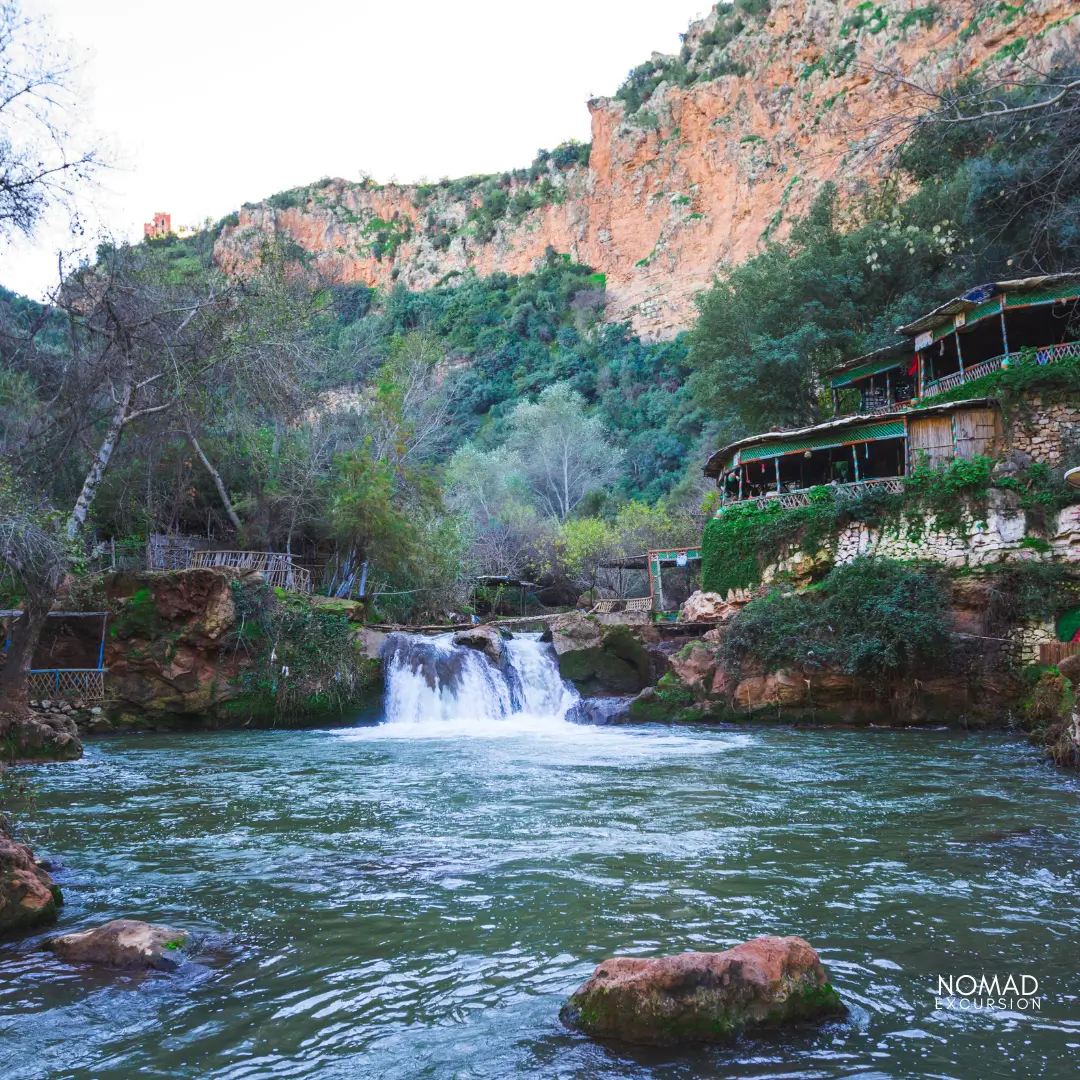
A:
216,0,1080,337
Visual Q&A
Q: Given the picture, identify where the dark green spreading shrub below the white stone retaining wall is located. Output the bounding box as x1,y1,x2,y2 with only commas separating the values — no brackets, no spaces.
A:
721,558,948,678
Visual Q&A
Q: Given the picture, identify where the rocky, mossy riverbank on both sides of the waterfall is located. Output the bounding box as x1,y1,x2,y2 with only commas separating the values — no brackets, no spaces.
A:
16,569,1080,764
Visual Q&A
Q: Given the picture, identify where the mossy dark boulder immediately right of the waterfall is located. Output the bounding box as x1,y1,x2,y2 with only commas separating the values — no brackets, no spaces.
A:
552,611,652,696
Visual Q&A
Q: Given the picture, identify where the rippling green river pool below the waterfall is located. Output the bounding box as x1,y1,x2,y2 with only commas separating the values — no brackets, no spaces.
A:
0,720,1080,1080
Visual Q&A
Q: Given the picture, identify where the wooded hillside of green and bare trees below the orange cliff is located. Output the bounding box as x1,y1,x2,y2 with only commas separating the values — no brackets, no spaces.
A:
0,5,1080,617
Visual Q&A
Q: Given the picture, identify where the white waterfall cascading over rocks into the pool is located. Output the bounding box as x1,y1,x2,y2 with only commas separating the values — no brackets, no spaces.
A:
383,634,578,728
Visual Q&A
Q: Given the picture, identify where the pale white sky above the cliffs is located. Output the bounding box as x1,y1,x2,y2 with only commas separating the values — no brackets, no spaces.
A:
0,0,710,296
